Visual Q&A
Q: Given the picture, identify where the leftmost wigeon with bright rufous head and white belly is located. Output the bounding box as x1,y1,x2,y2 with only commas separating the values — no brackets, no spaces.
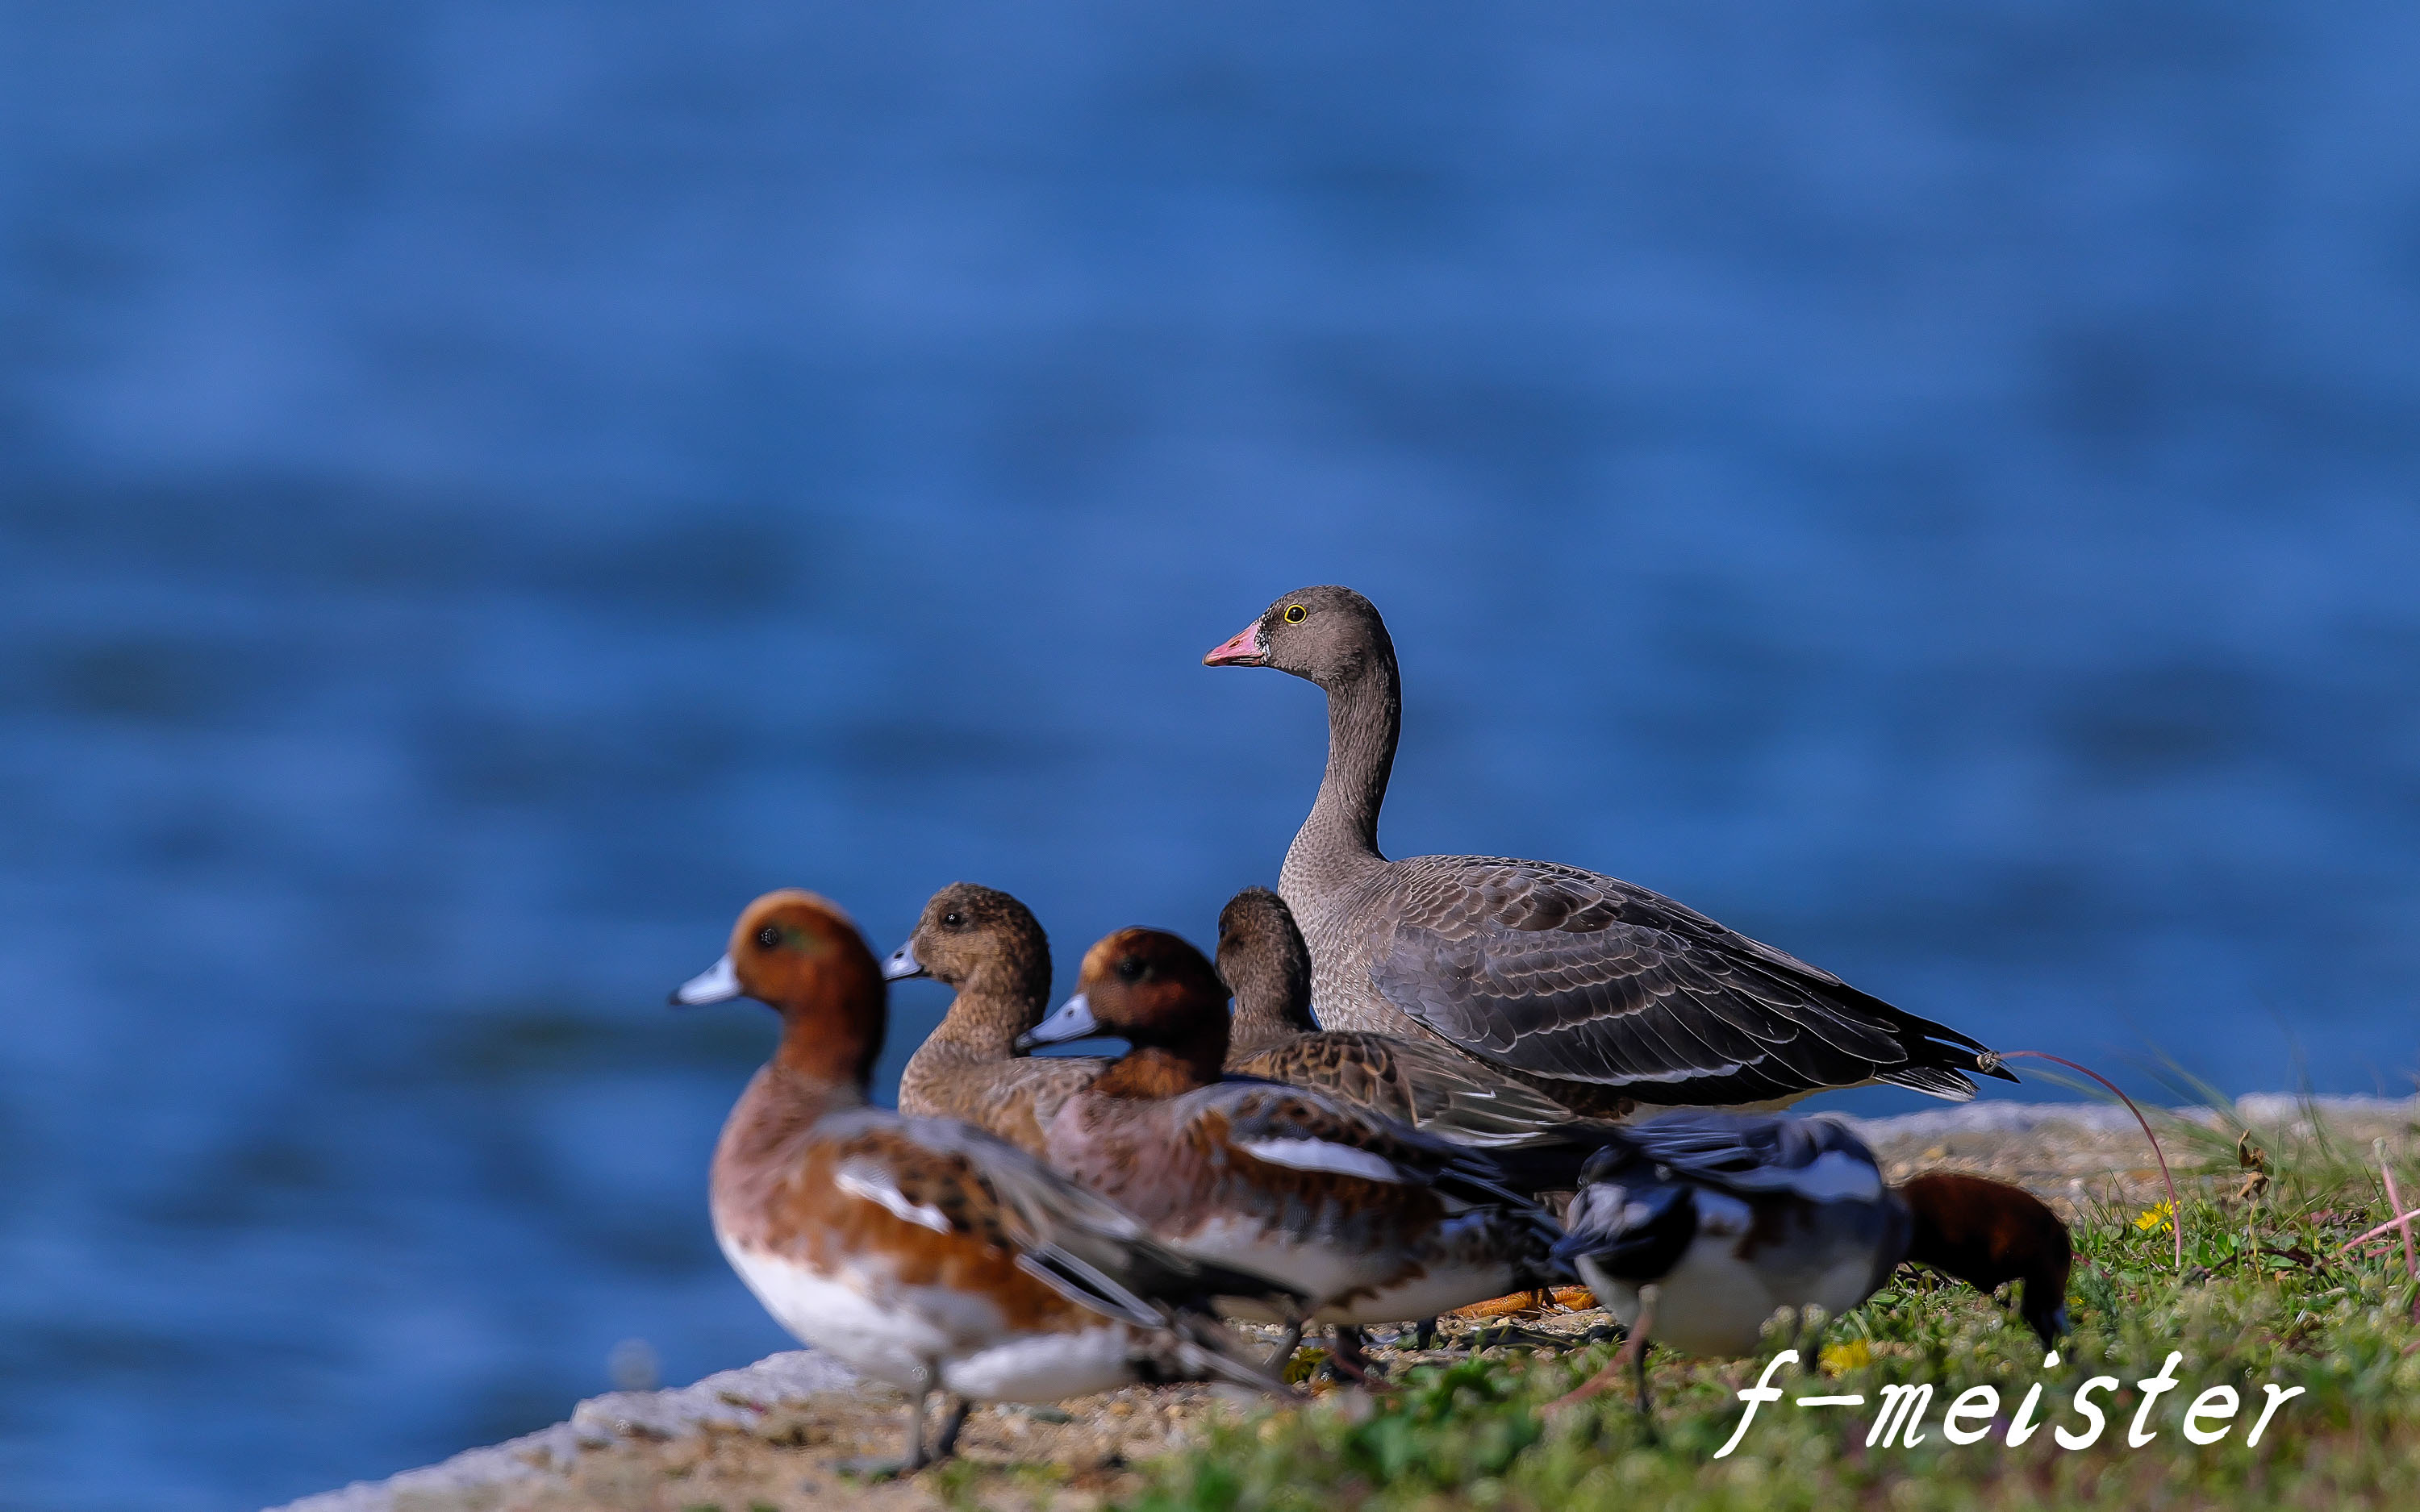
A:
673,890,1295,1468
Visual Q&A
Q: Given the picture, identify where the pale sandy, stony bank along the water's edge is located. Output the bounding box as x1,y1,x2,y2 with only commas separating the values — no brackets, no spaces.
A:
281,1096,2420,1512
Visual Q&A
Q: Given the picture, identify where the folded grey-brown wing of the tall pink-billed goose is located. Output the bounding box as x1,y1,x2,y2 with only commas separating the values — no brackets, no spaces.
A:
1370,856,2006,1103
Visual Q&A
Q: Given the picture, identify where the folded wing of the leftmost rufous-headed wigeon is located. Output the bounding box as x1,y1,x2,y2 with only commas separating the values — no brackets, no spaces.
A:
835,1118,1309,1328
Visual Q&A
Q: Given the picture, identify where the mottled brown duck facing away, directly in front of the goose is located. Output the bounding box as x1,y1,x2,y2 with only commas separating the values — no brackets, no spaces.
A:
1217,888,1609,1193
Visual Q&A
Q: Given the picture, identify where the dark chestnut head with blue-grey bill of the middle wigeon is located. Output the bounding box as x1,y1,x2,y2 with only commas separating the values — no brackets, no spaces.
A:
1016,929,1227,1096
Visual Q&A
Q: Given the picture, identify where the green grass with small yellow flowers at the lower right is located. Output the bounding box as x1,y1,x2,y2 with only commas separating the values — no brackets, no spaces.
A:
1128,1130,2420,1512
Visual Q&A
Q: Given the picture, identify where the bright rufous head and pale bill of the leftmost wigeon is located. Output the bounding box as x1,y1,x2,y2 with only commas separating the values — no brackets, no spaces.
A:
673,888,888,1091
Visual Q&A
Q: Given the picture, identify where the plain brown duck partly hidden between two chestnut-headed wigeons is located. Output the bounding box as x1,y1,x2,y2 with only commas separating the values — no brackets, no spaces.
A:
883,883,1108,1154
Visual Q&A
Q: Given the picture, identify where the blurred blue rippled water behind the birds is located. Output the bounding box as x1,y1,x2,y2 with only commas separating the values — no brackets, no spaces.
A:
14,0,2420,1512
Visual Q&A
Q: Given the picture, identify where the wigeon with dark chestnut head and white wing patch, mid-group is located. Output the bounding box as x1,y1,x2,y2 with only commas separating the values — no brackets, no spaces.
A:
1007,929,1558,1374
